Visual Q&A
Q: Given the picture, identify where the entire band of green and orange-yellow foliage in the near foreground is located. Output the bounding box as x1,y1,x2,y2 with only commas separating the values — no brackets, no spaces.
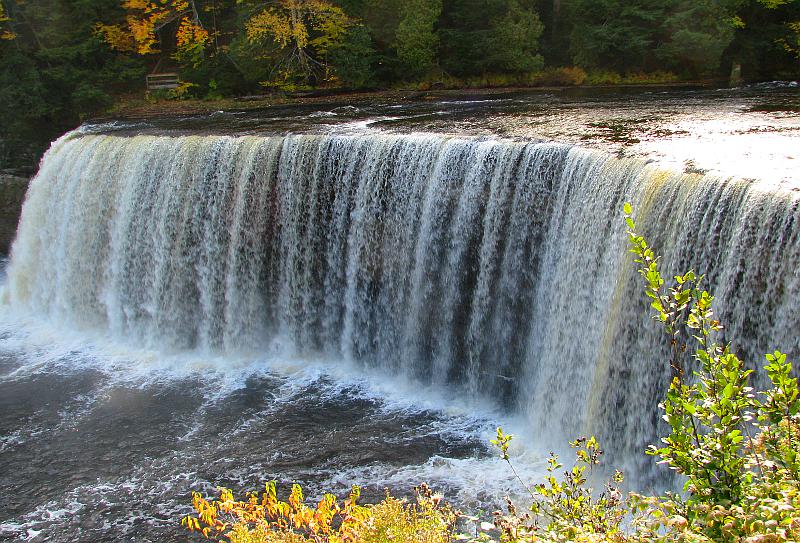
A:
182,204,800,543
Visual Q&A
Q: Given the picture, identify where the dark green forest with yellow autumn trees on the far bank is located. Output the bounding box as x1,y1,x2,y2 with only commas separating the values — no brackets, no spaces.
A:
0,0,800,173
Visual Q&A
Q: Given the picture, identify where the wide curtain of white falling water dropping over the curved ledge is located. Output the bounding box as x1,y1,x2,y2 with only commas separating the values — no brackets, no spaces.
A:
8,134,800,484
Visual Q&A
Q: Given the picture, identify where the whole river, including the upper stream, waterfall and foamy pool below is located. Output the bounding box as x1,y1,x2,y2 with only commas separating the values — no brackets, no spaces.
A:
0,85,800,542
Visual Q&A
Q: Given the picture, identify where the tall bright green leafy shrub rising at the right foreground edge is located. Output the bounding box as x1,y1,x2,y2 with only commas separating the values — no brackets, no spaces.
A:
625,204,800,543
